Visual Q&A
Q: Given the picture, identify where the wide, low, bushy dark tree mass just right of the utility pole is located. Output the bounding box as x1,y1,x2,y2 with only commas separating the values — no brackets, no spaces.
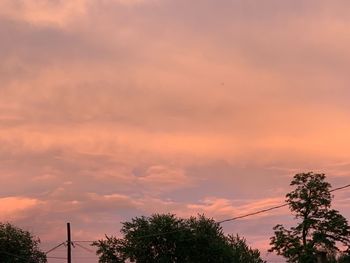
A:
94,214,264,263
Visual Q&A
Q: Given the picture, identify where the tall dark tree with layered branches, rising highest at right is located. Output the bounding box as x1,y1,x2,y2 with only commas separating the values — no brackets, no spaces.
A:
270,172,350,263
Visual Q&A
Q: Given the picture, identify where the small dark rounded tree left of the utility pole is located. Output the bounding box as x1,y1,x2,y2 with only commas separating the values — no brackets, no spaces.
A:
0,223,47,263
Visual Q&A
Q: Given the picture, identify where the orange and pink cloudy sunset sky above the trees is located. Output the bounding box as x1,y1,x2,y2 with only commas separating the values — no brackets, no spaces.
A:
0,0,350,263
